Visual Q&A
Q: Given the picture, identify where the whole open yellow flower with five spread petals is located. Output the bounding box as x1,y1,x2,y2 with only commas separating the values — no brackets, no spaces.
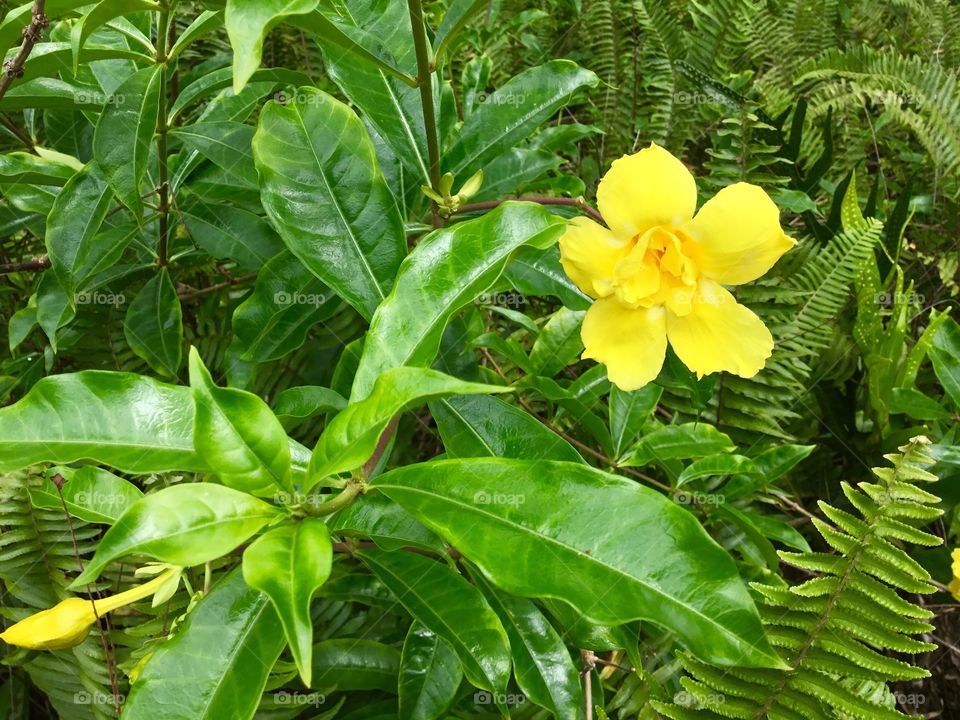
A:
560,144,796,390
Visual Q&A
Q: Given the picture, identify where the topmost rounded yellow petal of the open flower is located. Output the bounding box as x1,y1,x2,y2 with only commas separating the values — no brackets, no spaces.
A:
597,143,697,237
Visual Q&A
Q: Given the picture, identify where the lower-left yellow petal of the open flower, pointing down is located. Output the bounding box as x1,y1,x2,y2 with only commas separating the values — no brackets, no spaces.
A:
580,298,667,390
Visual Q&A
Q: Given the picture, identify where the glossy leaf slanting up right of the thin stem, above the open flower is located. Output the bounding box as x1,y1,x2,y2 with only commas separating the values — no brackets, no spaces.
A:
444,60,600,177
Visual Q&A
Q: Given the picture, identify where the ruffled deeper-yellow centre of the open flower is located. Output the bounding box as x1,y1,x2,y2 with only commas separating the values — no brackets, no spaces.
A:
613,225,700,315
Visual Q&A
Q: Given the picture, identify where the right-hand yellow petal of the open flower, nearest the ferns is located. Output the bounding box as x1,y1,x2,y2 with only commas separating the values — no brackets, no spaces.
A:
683,183,797,285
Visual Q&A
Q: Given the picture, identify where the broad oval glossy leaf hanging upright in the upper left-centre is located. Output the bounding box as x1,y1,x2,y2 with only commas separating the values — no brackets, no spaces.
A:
253,87,406,319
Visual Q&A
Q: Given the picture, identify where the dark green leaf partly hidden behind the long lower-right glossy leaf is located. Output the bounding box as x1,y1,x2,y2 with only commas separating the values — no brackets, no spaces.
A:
430,395,583,463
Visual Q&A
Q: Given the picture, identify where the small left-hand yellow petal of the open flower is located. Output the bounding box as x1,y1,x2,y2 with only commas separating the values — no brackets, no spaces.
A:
560,217,631,298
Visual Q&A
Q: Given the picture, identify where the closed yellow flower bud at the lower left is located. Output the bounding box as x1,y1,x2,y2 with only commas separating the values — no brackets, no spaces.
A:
0,568,180,650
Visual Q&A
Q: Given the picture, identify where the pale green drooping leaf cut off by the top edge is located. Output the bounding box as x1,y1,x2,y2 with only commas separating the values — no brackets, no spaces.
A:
223,0,319,93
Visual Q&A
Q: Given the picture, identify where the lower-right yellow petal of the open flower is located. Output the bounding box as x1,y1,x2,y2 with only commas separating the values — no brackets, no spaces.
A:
667,278,773,377
